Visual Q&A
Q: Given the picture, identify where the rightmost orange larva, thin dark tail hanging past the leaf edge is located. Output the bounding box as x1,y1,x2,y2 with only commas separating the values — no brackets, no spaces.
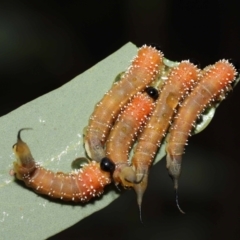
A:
166,60,237,199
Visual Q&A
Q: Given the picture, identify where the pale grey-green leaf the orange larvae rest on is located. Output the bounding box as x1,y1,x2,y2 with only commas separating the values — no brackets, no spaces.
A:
0,43,238,240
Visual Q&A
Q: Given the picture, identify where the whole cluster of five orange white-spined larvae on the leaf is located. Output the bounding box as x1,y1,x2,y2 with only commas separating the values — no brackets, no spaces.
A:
13,46,237,217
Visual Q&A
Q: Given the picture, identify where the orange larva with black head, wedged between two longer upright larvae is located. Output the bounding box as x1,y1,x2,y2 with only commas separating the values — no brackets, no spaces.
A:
106,87,158,187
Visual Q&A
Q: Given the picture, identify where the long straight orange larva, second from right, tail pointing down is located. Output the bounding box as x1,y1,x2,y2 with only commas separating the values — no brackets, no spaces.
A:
132,61,199,211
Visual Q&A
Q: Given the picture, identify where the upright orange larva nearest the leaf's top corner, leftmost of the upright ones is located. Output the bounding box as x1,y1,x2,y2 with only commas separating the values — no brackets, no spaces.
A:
84,45,163,162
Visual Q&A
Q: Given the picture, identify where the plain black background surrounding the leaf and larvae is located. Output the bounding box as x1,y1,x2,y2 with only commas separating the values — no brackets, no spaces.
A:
0,0,240,240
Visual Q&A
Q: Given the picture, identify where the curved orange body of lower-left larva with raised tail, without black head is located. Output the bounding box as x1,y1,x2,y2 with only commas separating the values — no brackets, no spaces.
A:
13,129,111,202
